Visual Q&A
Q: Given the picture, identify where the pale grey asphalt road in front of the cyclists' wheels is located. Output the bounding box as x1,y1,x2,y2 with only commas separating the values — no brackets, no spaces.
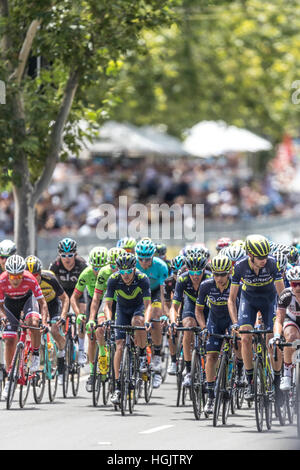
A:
0,368,300,451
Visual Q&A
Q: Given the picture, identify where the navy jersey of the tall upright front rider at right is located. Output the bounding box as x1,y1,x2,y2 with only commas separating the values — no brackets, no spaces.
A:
232,256,282,303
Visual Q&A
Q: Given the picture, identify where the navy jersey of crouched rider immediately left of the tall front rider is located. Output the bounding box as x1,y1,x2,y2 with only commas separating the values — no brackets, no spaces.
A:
196,278,237,319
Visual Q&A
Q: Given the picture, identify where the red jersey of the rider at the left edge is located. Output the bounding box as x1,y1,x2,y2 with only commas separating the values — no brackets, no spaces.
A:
0,271,43,302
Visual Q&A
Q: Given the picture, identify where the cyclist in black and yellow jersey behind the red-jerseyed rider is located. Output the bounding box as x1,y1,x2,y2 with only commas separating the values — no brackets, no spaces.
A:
25,256,69,385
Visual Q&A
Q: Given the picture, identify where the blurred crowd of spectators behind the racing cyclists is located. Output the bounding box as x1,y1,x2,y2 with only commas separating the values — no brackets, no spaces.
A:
0,155,300,236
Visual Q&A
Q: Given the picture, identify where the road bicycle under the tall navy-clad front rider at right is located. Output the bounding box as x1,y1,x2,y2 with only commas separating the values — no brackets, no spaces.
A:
239,329,275,432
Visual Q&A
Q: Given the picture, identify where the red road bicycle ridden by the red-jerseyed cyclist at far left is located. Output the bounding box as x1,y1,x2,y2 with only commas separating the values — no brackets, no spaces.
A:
6,323,40,410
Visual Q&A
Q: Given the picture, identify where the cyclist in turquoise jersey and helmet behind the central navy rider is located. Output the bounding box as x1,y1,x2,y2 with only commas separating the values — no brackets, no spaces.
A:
135,238,168,388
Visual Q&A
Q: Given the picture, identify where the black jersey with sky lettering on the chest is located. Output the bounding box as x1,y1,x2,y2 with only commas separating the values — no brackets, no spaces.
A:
49,255,87,297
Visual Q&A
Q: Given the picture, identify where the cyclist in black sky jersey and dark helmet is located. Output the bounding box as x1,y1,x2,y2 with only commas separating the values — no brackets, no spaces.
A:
49,238,87,365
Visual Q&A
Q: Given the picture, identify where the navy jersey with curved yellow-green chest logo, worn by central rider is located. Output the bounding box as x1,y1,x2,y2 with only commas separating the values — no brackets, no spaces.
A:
105,270,151,310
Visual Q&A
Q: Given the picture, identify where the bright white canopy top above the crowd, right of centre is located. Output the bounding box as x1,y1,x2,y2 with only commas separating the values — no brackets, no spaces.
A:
183,121,272,158
